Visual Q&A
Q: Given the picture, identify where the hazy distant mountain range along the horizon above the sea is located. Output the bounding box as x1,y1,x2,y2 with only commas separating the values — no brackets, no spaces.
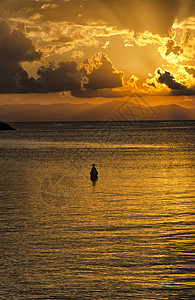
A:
0,101,195,122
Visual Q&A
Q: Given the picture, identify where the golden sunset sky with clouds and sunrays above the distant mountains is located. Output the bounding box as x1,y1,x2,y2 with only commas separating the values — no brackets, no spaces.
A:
0,0,195,120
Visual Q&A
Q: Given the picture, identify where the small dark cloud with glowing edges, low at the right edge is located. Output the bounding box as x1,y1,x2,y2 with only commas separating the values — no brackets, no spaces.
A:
158,70,195,96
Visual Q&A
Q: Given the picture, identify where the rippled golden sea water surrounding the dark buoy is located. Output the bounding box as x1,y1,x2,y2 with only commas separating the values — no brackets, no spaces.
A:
0,122,195,300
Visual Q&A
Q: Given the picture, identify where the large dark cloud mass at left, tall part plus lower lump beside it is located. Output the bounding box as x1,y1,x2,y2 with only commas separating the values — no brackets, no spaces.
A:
0,22,81,93
